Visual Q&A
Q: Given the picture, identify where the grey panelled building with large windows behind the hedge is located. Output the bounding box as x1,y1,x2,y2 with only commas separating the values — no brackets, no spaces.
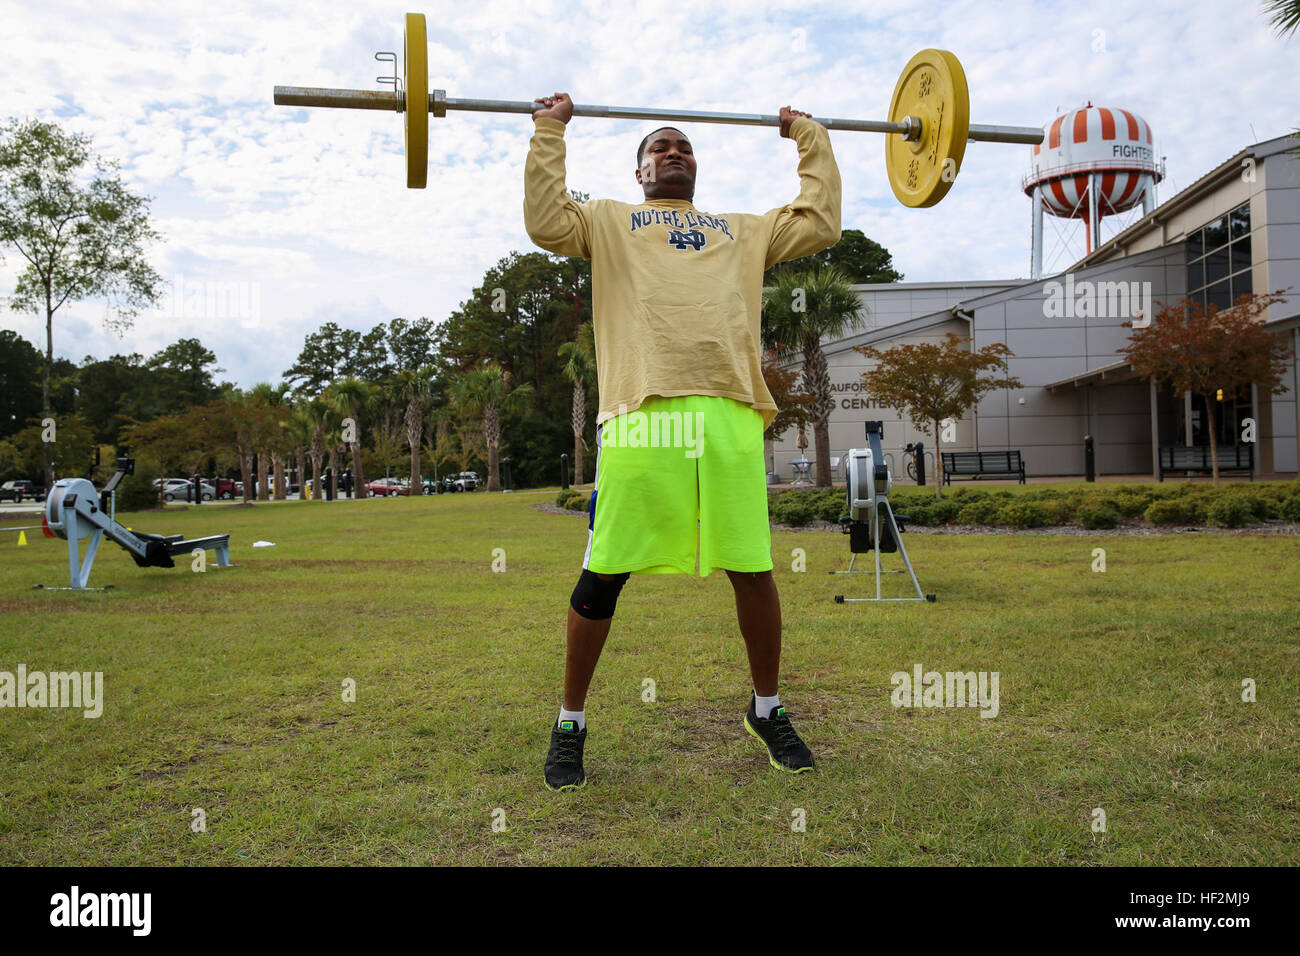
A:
768,130,1300,480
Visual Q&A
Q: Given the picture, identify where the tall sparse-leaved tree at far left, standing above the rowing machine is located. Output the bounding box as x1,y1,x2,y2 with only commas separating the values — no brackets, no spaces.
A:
0,120,161,485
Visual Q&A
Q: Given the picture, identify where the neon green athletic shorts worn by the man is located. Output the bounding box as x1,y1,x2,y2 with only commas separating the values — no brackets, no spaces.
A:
582,395,772,578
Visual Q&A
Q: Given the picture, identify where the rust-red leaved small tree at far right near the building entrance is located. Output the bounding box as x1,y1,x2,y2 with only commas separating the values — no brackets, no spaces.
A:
1117,290,1291,485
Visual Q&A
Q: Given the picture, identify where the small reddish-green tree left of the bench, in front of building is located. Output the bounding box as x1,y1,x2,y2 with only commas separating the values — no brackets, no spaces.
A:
853,332,1021,498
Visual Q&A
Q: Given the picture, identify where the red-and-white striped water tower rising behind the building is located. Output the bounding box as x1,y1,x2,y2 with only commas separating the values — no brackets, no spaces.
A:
1023,103,1165,278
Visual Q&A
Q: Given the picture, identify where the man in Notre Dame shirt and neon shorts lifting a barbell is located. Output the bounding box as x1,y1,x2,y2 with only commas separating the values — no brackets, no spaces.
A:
524,94,840,791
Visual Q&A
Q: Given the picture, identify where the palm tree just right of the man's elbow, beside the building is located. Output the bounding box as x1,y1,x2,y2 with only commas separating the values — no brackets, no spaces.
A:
763,267,865,488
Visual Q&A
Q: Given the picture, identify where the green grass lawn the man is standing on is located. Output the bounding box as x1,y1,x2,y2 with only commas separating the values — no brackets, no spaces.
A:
0,492,1300,865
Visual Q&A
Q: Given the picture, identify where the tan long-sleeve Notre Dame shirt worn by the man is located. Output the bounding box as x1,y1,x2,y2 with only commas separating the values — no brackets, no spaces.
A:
524,117,840,429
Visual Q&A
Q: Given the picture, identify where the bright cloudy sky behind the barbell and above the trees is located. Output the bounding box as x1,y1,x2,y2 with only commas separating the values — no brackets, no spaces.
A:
0,0,1300,386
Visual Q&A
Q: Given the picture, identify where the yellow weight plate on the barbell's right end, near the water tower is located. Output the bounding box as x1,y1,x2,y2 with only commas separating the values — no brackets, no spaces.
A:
885,49,971,207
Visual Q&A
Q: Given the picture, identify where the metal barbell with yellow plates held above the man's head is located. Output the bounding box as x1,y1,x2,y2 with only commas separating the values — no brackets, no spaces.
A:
274,13,1043,207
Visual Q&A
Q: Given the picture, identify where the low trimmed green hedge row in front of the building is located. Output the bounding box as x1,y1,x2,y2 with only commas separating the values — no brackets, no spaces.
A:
767,481,1300,529
